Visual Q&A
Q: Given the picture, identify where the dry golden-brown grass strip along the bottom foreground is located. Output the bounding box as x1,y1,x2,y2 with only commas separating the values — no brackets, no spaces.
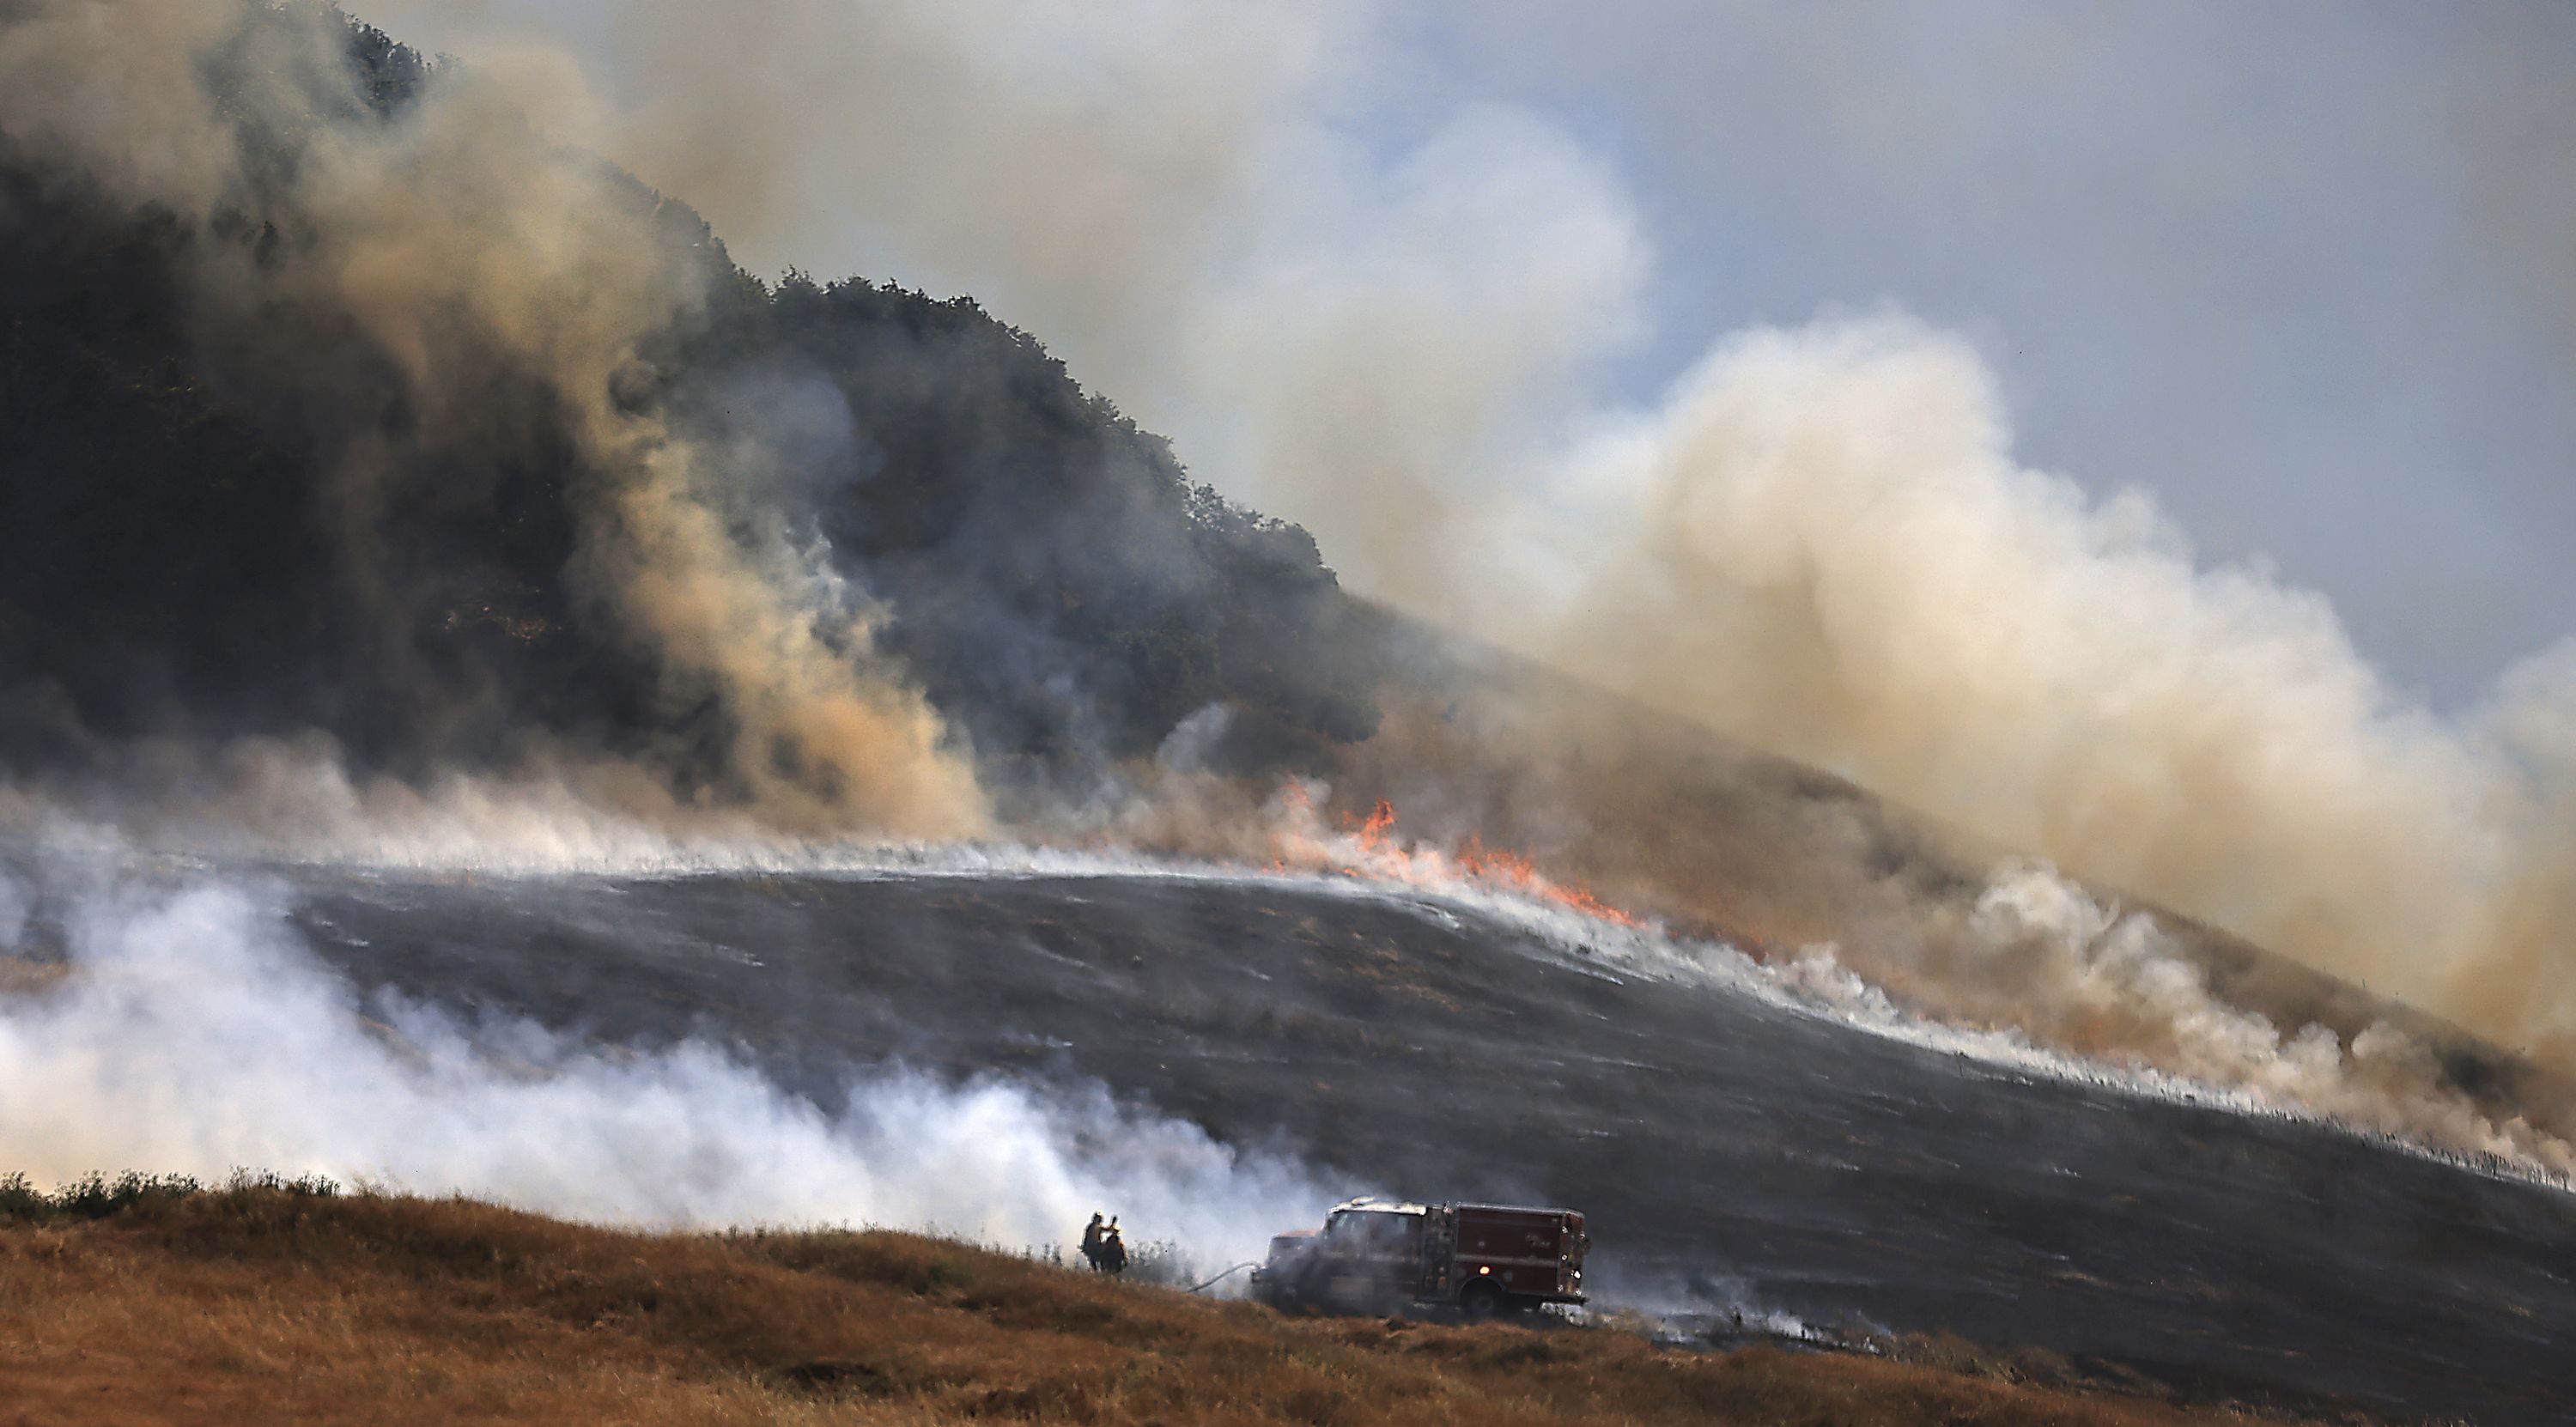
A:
0,1190,2339,1427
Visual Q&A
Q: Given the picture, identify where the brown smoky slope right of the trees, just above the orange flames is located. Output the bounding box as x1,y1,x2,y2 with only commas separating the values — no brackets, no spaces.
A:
1332,616,2576,1133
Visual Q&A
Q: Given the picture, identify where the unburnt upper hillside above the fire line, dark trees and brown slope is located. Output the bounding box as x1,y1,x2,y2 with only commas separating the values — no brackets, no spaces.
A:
0,0,2576,1169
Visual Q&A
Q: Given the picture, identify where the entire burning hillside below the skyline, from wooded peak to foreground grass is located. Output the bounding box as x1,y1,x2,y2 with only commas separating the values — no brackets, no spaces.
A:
0,0,2576,1427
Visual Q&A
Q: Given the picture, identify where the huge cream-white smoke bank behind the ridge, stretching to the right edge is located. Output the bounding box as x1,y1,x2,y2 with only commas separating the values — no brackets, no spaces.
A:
433,0,2576,1061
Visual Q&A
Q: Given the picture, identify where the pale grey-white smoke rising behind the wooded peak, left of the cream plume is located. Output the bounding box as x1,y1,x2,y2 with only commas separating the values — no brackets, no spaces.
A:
381,0,1649,623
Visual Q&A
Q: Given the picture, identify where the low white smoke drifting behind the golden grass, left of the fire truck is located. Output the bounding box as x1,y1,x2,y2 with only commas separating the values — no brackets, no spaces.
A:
0,860,1334,1260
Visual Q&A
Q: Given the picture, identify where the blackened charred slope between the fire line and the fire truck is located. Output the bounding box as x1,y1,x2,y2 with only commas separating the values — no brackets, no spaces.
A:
266,873,2576,1427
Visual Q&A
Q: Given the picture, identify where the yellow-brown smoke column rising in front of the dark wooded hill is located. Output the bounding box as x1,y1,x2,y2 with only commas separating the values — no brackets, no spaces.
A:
0,0,984,837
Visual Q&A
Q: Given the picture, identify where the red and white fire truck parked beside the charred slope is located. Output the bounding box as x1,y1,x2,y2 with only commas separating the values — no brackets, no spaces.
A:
1252,1198,1592,1319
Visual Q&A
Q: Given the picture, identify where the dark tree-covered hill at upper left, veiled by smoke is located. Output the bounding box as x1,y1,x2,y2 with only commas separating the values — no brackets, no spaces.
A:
0,3,1376,814
